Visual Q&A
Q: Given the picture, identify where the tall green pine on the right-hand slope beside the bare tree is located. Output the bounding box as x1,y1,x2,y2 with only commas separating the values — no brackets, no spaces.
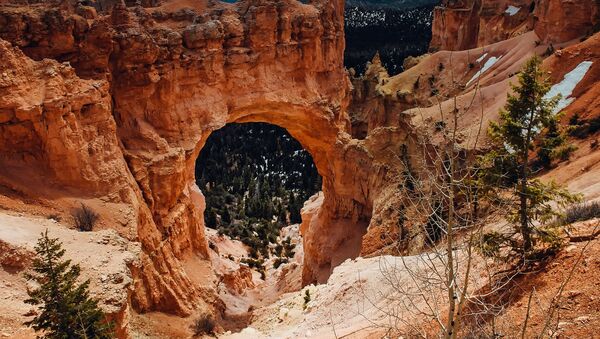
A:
483,57,577,255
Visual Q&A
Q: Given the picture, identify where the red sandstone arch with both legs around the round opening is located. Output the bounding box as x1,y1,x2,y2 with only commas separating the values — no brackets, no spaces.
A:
102,0,371,312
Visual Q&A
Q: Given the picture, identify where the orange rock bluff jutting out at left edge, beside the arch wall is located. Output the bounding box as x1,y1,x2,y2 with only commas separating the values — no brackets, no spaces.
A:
0,41,128,199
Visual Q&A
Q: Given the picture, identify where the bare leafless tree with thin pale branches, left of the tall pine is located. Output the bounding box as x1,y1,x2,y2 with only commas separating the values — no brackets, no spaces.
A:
356,54,516,338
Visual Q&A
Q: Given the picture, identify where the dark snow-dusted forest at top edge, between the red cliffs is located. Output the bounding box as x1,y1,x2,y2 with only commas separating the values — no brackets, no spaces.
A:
345,0,439,74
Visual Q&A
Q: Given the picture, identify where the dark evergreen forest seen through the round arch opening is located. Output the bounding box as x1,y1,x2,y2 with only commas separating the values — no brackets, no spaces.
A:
196,123,321,256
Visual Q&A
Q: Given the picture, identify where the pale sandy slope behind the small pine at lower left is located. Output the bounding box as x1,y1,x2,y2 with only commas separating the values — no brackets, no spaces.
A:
0,211,141,338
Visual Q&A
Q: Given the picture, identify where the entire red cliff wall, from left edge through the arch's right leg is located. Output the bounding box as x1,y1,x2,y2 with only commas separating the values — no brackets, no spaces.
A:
0,0,372,314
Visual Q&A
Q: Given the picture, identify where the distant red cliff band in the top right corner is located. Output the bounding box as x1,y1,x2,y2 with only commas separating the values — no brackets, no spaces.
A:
430,0,600,50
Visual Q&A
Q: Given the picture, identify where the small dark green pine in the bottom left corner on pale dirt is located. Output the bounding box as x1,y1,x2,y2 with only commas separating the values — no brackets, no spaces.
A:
25,230,113,339
